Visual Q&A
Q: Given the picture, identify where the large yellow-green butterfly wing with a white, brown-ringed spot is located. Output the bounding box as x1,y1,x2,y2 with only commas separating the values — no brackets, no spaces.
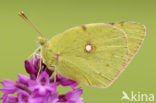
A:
42,24,128,87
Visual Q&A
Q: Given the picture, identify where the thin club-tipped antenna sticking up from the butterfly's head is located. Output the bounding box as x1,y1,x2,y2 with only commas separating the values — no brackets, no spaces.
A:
18,11,43,37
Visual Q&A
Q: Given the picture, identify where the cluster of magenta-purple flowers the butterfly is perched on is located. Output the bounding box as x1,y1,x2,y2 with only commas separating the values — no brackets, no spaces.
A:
0,56,84,103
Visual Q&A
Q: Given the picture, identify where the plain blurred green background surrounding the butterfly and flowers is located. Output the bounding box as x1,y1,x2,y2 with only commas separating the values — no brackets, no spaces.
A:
0,0,156,103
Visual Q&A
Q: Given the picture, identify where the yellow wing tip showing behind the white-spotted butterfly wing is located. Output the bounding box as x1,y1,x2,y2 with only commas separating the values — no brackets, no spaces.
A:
110,22,146,62
